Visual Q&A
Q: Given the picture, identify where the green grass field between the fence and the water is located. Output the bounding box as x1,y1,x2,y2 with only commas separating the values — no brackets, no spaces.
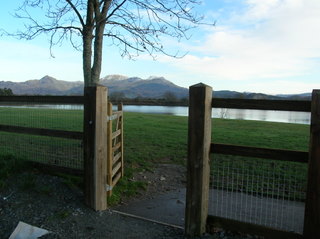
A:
0,108,309,201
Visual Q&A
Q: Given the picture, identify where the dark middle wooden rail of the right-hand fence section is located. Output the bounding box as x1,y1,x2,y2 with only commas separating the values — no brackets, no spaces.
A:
210,143,309,163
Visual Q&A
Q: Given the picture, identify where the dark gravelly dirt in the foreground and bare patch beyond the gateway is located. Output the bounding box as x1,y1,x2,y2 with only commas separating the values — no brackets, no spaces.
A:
0,164,260,239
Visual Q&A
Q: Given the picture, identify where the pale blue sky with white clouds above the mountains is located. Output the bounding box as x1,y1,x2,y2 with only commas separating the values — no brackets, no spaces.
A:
0,0,320,94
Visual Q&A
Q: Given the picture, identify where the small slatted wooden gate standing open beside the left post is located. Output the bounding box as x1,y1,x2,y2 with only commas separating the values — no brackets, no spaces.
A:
107,102,124,196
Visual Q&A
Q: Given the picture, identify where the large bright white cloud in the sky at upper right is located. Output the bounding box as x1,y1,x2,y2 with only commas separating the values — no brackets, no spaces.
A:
159,0,320,91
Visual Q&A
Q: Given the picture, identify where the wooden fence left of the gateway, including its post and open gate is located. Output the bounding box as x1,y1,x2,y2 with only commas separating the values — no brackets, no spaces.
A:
0,86,123,210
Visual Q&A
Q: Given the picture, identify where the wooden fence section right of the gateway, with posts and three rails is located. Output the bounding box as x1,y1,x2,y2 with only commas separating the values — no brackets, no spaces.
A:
185,84,320,238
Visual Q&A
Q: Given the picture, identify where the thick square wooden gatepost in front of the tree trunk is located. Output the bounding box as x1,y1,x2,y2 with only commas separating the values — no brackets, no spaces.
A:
83,85,108,210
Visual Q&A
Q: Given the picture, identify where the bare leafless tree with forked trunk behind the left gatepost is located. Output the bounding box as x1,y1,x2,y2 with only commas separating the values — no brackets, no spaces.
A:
5,0,211,86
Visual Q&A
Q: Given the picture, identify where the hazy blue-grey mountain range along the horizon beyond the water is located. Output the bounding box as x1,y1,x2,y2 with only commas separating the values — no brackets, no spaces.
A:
0,75,311,100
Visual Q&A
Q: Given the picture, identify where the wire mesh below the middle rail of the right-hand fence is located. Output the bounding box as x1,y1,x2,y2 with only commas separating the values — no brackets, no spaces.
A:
209,155,307,233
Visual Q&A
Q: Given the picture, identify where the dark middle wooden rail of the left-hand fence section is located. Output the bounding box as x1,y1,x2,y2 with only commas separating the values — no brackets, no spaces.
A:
0,125,83,140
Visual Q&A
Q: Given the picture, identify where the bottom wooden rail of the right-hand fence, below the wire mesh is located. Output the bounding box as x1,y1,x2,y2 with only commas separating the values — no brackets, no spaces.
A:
207,215,303,239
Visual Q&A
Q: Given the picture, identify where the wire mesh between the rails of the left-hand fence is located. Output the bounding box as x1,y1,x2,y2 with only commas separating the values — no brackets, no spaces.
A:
0,98,83,169
